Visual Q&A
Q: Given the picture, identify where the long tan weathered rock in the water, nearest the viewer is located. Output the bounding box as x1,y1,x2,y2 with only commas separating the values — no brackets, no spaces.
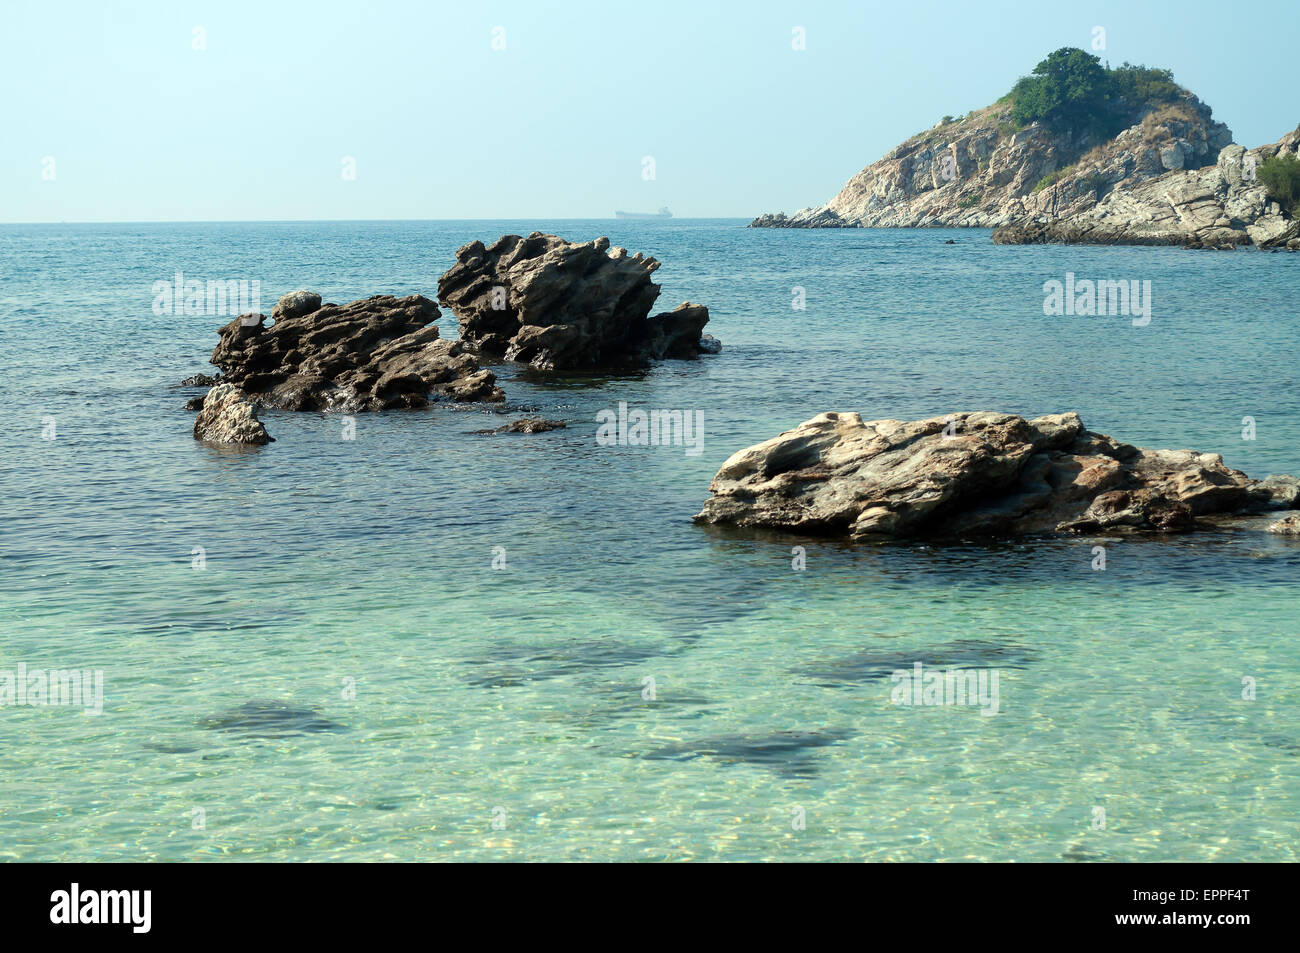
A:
696,412,1294,538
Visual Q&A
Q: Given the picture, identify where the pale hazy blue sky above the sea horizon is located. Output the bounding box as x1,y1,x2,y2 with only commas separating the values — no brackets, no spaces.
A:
0,0,1300,222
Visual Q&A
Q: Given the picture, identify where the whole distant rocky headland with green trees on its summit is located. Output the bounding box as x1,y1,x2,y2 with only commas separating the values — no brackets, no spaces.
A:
750,48,1300,248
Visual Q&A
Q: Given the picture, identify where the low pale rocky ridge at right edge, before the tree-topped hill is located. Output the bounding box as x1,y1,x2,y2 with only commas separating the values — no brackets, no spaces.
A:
993,129,1300,250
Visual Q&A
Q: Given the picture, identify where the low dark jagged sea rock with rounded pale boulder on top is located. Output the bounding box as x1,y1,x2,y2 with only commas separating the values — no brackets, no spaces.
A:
212,291,504,411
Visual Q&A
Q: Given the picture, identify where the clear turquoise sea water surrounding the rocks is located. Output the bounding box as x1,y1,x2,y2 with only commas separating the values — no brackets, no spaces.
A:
0,221,1300,861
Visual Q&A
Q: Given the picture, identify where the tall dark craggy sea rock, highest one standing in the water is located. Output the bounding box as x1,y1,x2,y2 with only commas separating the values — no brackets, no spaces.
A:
438,231,709,371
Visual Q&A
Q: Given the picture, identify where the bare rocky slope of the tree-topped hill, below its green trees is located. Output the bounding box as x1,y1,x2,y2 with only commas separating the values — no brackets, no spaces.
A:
751,90,1232,228
